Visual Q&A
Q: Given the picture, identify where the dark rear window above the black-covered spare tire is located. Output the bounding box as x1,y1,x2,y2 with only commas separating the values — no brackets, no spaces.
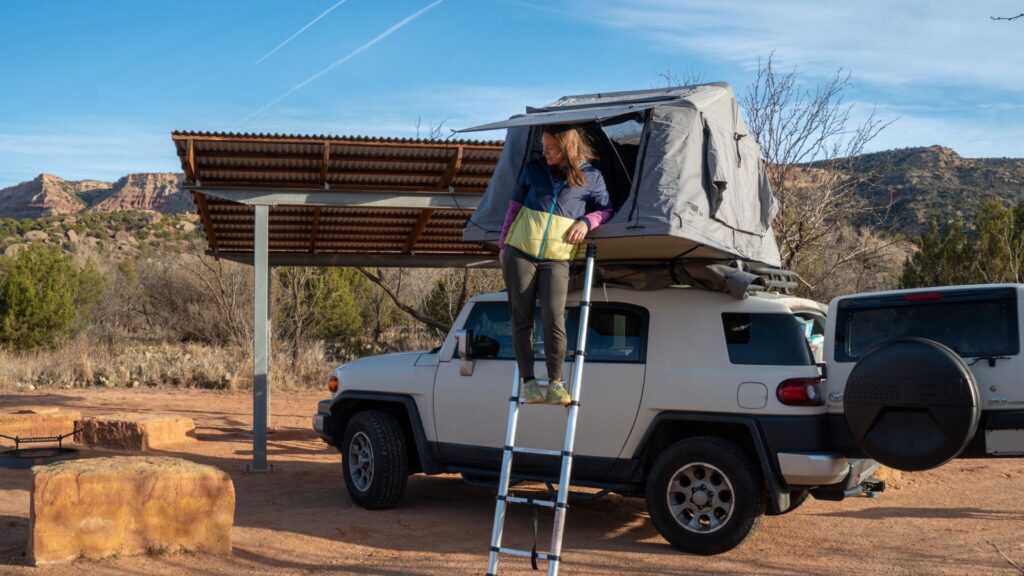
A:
836,289,1020,362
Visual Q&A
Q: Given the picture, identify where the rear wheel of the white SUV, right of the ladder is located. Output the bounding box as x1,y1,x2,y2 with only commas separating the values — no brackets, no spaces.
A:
646,437,765,556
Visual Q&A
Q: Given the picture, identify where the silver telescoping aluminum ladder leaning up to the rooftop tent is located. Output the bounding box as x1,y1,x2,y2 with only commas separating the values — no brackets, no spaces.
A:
487,244,597,576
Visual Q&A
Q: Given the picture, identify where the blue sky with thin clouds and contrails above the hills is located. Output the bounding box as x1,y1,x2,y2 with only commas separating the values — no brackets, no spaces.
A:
0,0,1024,188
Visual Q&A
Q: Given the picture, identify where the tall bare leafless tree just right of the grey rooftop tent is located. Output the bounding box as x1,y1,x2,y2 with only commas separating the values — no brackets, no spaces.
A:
741,54,892,296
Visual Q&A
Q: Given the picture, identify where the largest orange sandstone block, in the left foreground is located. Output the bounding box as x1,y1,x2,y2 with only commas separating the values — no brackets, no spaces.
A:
29,456,234,566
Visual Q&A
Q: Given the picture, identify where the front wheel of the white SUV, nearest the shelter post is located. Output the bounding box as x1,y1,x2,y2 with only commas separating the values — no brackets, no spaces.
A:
341,411,409,510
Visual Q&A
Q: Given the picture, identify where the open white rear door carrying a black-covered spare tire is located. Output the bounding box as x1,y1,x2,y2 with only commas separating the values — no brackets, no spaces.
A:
825,284,1024,470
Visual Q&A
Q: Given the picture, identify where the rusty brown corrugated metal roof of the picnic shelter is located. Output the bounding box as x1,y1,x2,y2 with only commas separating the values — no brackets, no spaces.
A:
171,131,502,265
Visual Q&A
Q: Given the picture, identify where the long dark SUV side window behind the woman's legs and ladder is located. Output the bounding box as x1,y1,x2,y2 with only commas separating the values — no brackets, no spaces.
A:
465,302,647,363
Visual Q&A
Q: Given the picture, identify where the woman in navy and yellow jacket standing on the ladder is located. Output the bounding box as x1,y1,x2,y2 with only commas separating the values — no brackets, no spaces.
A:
498,126,611,406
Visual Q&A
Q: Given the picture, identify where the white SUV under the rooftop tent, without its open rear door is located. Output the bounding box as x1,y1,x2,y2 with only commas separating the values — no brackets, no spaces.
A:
313,287,884,554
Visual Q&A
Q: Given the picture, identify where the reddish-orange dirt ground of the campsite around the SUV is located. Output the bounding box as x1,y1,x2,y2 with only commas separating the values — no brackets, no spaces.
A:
0,389,1024,576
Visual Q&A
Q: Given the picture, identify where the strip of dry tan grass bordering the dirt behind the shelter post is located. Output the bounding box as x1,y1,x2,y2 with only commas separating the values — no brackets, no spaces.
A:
0,337,337,390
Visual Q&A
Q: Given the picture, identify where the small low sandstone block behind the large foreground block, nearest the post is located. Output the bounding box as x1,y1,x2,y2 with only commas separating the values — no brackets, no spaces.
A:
75,414,196,452
